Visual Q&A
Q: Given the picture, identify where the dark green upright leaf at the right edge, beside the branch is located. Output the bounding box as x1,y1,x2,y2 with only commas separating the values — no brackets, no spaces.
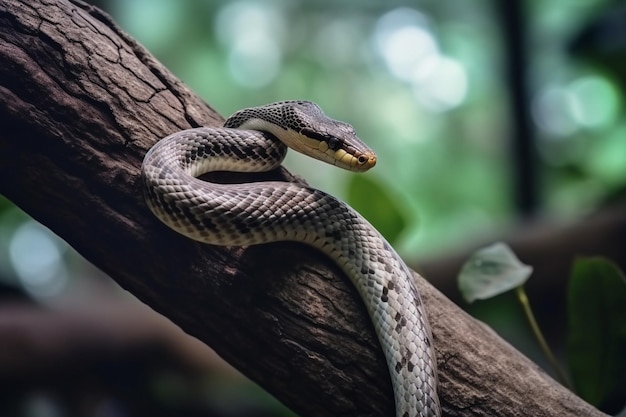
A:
567,258,626,413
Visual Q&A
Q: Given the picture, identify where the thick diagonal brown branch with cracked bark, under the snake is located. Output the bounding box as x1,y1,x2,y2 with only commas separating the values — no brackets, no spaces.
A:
0,0,602,416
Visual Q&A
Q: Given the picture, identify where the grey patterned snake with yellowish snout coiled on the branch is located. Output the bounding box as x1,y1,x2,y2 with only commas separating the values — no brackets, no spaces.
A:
141,100,441,417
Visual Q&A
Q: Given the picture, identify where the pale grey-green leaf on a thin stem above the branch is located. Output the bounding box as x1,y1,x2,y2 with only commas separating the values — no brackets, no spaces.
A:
459,243,533,303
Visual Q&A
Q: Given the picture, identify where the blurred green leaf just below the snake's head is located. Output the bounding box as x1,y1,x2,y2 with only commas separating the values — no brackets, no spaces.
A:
348,175,407,244
